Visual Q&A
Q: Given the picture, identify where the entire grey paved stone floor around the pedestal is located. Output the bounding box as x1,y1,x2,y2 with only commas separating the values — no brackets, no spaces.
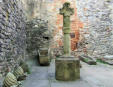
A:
0,60,113,87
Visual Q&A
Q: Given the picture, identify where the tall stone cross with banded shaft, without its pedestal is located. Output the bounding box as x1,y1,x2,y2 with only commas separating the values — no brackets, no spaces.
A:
60,2,74,56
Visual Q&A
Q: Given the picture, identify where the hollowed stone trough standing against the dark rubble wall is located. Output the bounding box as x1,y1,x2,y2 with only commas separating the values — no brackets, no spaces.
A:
38,48,50,66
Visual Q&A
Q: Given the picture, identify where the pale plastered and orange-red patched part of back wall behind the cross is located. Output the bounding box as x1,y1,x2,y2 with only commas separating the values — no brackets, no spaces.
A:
22,0,83,57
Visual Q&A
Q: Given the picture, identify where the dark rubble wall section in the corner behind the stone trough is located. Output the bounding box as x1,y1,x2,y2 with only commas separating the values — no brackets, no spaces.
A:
26,18,52,58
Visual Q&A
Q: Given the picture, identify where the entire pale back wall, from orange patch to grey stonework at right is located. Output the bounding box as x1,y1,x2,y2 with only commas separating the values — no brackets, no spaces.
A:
22,0,113,57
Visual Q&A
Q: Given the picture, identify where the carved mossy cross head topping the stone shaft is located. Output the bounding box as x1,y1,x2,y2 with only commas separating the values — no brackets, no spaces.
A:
60,2,74,16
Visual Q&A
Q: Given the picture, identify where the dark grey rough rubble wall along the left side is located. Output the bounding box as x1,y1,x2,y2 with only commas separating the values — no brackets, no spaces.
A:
0,0,26,75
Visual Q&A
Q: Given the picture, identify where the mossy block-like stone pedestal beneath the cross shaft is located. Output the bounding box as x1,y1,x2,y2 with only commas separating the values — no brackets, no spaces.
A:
55,57,80,81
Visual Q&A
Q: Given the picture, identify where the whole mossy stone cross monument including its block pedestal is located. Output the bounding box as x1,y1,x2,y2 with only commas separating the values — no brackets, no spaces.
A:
55,2,80,81
